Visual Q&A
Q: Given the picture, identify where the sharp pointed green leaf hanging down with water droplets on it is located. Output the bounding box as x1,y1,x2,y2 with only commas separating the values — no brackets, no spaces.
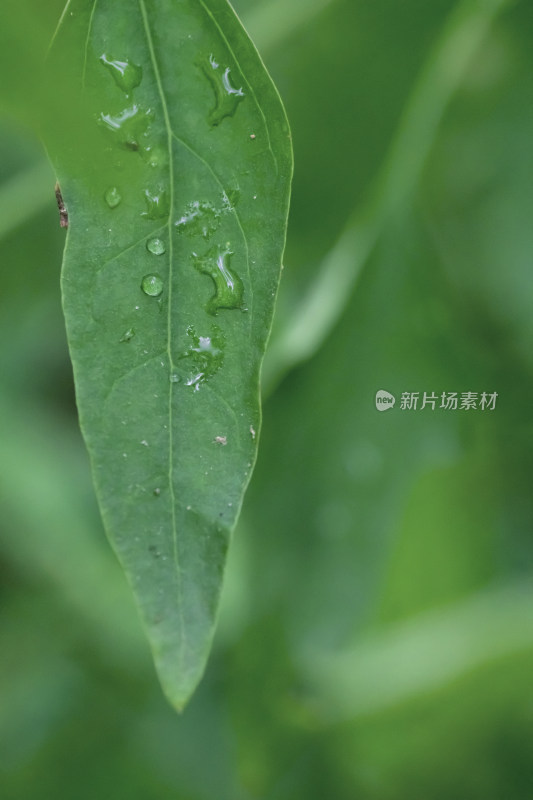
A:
47,0,292,708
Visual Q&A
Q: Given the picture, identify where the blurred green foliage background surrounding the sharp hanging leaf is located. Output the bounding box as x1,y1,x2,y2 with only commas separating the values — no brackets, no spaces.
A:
0,0,533,800
